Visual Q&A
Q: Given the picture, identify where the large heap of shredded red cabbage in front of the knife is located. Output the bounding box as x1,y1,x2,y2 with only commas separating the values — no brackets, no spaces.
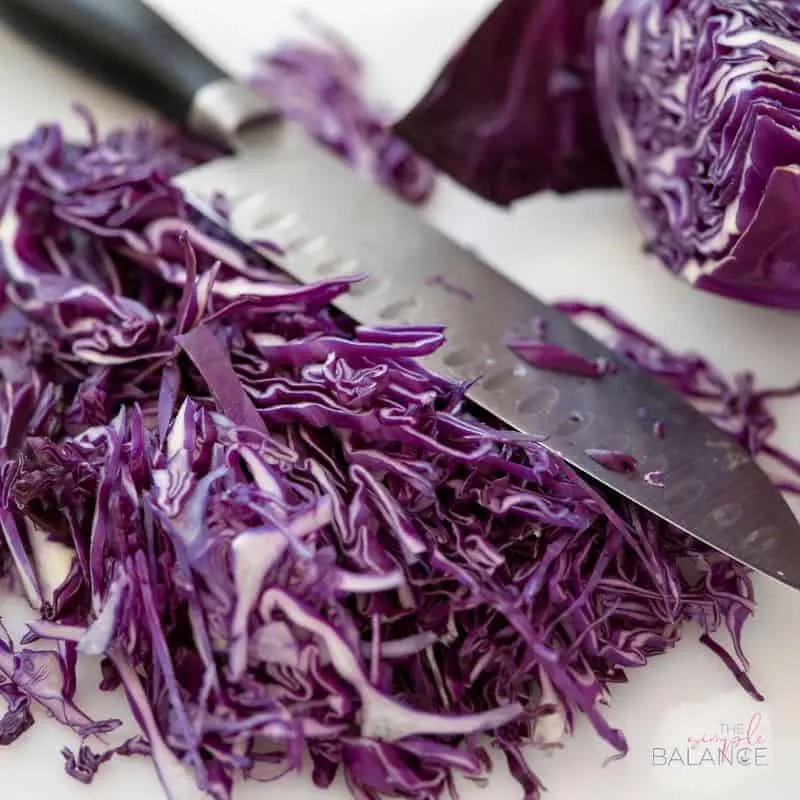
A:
0,117,755,800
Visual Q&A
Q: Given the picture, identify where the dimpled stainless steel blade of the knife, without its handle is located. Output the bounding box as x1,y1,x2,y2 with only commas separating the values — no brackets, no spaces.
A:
177,123,800,588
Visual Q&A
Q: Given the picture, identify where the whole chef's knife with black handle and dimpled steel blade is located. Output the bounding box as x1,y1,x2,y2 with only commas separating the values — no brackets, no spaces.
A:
0,0,800,588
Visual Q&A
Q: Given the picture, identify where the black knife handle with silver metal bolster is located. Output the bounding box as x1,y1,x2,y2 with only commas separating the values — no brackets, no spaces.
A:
0,0,277,144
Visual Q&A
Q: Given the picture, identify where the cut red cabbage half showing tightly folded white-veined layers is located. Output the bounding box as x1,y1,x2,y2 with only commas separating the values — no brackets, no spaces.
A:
596,0,800,309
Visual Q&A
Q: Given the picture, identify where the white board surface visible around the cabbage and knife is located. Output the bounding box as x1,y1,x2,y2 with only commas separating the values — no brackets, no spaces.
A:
0,0,800,800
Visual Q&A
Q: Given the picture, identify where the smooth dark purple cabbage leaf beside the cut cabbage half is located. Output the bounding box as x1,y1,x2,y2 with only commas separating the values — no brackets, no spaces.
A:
394,0,619,205
